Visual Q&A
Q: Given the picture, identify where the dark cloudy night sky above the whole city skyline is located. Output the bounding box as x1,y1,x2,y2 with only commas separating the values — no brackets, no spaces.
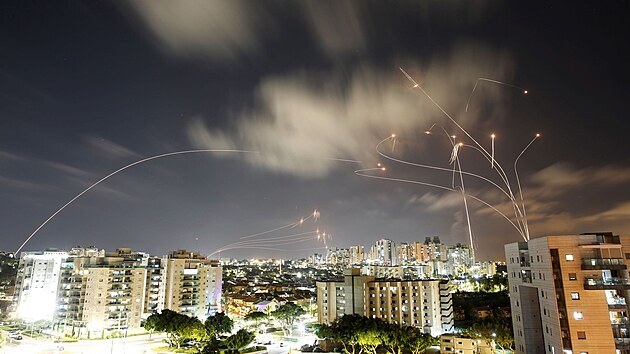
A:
0,0,630,259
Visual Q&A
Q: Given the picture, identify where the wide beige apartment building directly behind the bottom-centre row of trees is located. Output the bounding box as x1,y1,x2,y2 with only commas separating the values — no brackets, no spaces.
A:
317,269,453,335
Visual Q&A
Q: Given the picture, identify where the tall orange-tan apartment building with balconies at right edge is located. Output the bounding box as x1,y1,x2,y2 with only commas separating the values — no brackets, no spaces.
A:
505,232,630,354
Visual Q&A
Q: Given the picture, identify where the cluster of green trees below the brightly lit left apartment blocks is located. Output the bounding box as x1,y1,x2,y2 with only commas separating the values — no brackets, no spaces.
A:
144,309,255,352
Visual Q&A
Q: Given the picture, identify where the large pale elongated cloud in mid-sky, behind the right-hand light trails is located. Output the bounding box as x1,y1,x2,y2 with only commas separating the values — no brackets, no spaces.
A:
187,46,511,177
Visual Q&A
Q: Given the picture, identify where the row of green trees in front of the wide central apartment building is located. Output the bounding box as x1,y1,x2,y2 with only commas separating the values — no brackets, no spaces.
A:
316,315,438,354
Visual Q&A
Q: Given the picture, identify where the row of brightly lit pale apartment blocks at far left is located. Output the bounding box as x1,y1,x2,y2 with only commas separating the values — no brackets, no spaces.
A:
14,248,222,335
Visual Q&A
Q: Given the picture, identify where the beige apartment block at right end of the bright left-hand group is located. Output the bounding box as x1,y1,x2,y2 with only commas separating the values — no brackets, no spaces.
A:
158,250,223,319
